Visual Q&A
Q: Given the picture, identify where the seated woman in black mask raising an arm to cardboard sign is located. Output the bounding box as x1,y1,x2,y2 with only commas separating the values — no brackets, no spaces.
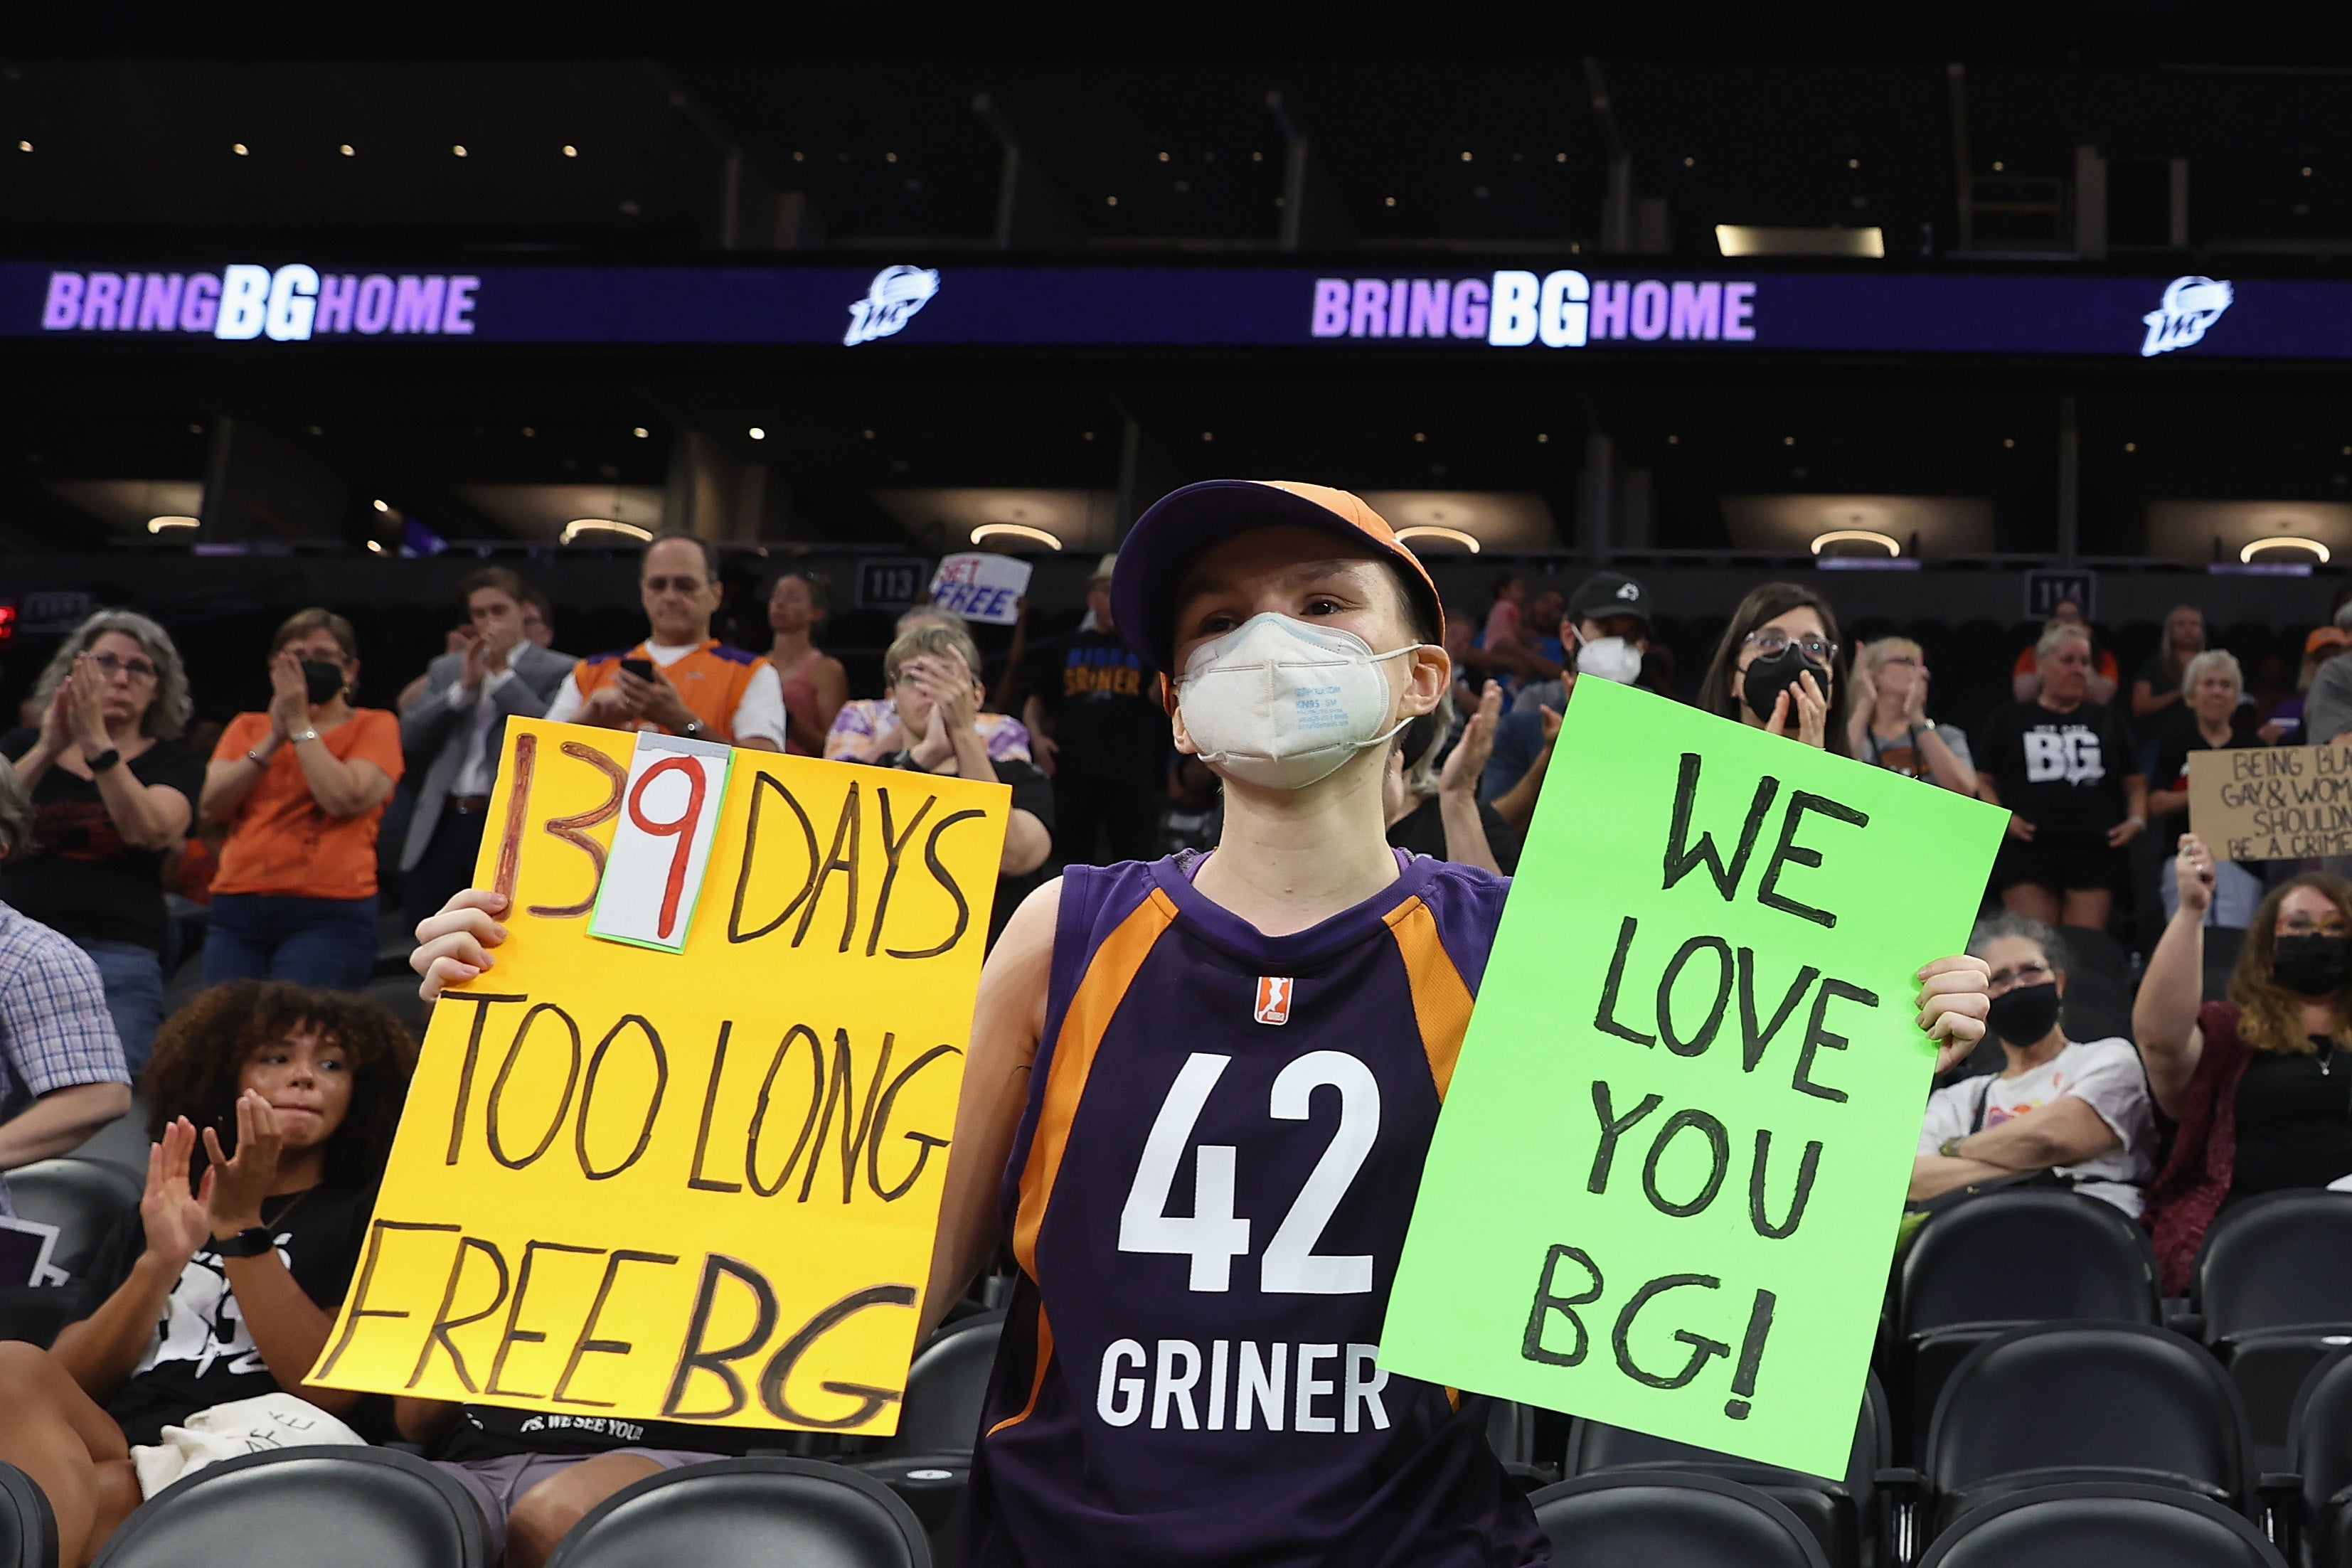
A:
2131,850,2352,1296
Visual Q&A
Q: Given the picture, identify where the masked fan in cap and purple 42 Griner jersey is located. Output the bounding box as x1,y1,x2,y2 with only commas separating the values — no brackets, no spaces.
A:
416,479,1985,1568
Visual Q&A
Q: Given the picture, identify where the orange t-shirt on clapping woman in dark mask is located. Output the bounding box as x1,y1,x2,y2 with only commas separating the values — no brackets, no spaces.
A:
212,708,400,898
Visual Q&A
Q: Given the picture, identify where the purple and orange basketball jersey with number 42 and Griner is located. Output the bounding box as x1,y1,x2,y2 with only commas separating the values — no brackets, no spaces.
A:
962,855,1550,1568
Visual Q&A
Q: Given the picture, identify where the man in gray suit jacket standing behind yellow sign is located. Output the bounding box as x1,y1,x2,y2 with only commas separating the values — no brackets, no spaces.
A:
400,567,574,924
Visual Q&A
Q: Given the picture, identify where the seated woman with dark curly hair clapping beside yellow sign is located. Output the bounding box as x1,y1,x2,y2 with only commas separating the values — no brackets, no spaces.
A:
0,981,416,1563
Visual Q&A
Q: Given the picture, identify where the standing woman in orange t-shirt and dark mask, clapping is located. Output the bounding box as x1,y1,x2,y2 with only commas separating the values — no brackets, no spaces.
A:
200,609,402,990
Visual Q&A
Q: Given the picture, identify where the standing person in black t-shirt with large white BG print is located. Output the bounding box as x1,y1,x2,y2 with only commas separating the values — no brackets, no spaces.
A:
1976,625,2147,929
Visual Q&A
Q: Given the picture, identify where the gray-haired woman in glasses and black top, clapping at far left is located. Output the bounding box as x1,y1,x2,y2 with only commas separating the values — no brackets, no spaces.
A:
0,609,205,1077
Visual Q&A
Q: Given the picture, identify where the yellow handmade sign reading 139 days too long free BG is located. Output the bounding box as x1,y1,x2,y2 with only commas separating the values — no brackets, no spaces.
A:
311,720,1009,1434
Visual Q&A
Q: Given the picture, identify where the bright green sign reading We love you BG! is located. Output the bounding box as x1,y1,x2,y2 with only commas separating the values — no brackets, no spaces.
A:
1380,679,2004,1476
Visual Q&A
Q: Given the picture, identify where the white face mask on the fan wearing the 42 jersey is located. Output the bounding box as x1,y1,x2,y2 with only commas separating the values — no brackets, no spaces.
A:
1176,612,1420,790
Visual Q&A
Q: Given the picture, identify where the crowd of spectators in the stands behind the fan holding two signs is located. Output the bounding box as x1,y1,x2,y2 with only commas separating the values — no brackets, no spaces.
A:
0,533,2352,1563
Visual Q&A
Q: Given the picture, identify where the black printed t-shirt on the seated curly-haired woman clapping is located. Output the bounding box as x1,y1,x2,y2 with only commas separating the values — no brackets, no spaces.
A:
75,1185,376,1444
